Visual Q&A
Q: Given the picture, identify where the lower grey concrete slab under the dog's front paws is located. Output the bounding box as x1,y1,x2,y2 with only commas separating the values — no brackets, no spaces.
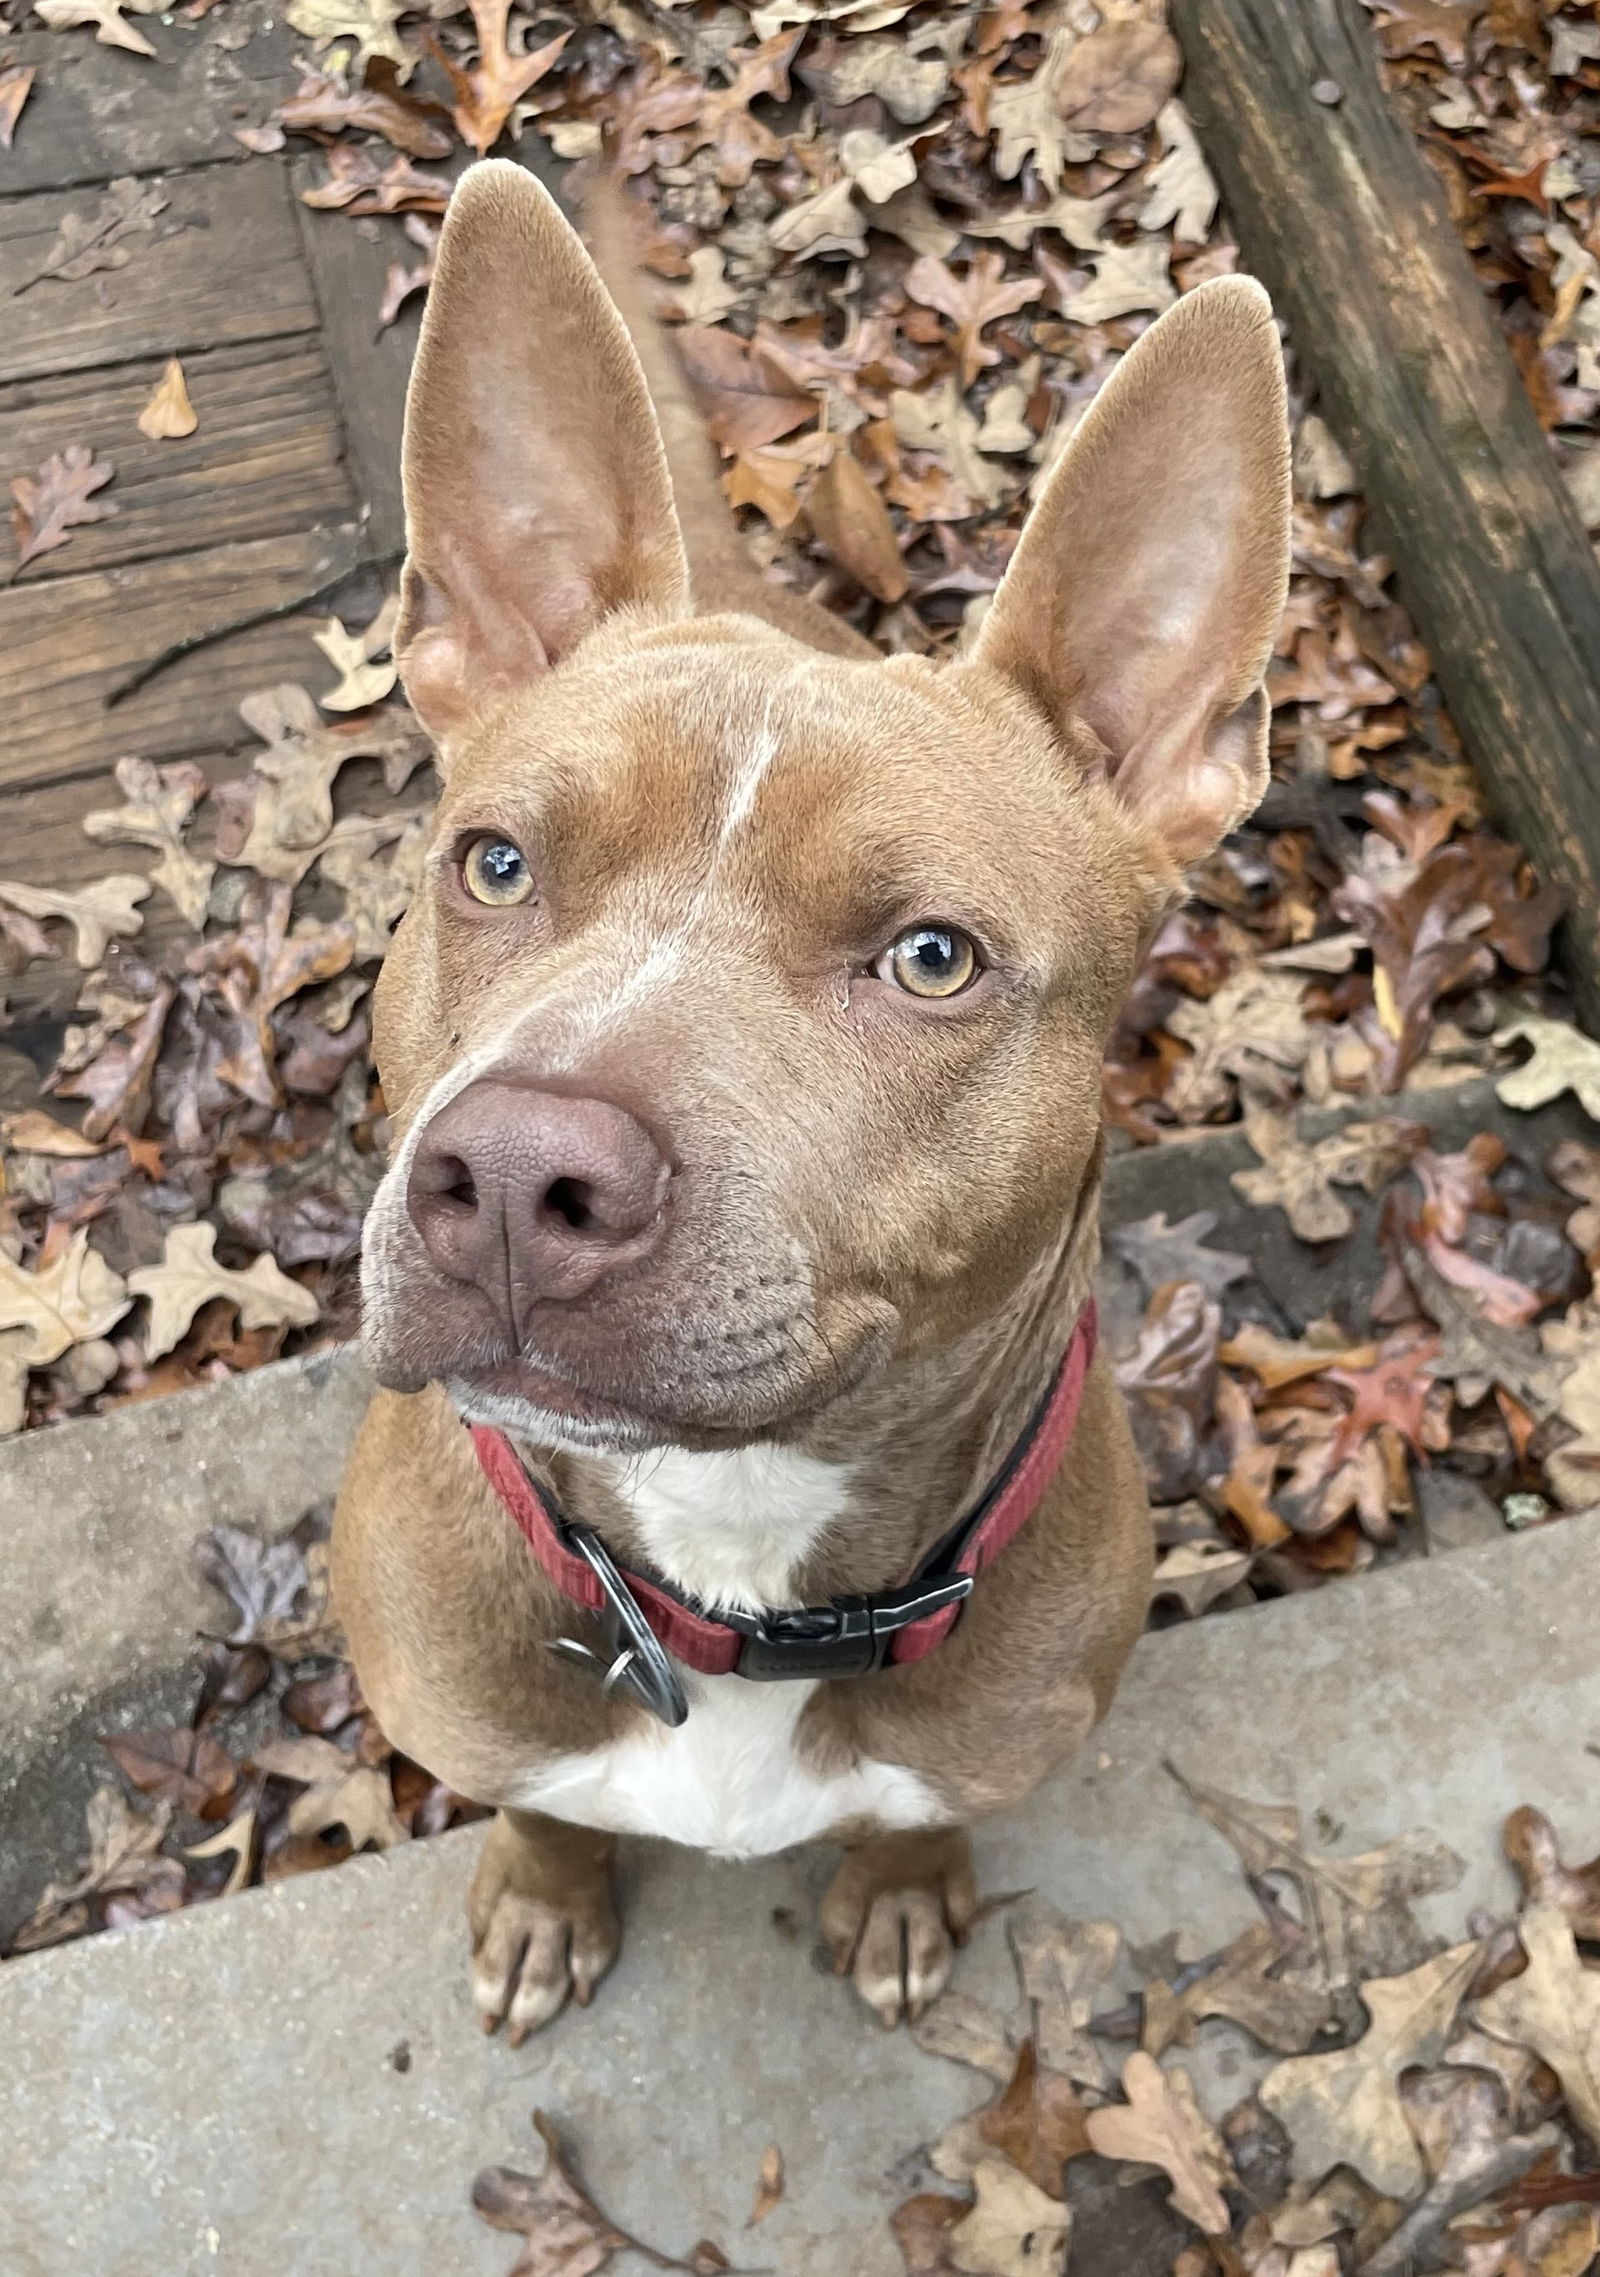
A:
0,1516,1600,2277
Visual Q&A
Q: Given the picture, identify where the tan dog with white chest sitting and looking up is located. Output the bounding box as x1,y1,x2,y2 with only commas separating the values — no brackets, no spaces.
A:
335,164,1288,2036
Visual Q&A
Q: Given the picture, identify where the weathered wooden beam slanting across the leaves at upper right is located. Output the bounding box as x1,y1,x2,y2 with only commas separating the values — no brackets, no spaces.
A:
1172,0,1600,1025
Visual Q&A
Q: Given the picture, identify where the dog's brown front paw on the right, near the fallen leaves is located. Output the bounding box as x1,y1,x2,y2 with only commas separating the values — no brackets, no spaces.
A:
822,1828,979,2029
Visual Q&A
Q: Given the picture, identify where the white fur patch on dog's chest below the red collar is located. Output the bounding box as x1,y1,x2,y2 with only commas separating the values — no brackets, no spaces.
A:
510,1676,949,1858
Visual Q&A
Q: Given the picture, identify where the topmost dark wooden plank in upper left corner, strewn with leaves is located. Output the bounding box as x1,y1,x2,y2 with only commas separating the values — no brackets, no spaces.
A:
0,0,303,191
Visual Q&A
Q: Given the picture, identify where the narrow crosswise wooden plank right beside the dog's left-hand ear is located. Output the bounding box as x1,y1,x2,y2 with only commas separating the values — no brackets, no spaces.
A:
291,132,564,553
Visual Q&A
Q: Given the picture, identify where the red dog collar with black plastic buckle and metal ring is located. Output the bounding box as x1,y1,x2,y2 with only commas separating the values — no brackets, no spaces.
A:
471,1300,1097,1678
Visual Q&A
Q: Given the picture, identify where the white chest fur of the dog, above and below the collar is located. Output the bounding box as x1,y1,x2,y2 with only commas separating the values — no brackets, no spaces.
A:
512,1448,945,1858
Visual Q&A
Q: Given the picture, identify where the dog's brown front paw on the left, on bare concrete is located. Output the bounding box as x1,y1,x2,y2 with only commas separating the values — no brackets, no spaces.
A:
467,1810,621,2047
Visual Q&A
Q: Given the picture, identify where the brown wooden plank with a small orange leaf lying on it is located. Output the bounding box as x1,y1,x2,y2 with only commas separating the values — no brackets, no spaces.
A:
0,337,355,585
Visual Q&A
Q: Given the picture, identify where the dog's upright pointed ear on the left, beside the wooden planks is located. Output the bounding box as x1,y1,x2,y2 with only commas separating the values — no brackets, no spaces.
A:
394,159,687,756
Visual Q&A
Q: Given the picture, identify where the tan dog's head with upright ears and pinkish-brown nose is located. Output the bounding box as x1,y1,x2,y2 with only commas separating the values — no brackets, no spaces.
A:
366,164,1288,1448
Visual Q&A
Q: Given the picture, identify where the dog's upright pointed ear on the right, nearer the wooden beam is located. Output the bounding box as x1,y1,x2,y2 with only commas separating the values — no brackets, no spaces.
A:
974,278,1290,865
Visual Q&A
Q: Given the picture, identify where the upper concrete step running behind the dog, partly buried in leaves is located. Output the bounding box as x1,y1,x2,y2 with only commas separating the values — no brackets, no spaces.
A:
0,1082,1591,1947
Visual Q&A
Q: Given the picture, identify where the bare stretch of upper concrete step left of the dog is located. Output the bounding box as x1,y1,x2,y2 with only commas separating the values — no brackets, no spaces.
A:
0,1346,369,1938
